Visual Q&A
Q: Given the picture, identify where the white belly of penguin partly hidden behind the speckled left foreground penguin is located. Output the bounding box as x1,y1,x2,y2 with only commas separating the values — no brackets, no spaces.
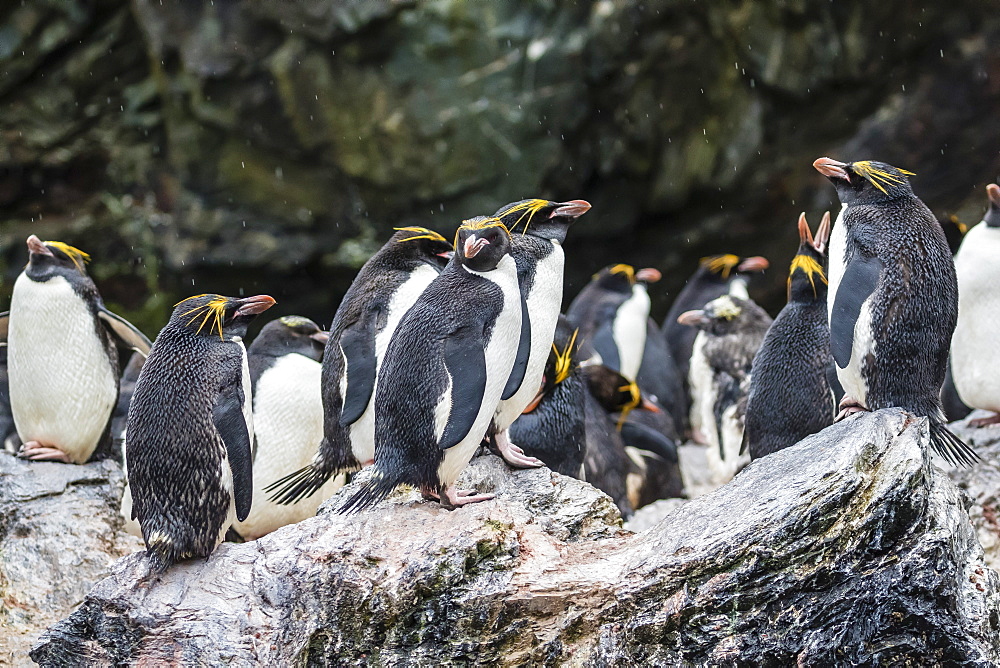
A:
235,353,344,540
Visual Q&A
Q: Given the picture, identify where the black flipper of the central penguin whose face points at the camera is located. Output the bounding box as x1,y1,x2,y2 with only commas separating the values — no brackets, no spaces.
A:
438,327,486,450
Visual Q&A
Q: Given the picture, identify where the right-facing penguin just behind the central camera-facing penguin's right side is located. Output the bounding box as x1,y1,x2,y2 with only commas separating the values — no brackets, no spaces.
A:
490,199,590,467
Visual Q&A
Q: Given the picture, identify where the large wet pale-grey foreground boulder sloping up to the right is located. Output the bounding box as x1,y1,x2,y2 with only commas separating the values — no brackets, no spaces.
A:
32,411,1000,666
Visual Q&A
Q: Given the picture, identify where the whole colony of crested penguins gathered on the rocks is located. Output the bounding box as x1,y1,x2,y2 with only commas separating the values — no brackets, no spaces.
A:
0,158,1000,573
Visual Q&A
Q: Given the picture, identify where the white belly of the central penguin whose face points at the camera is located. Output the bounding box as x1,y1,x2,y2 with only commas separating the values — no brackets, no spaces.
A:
438,255,521,487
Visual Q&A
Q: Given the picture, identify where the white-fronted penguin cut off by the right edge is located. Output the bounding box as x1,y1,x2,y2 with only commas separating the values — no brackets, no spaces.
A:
951,183,1000,427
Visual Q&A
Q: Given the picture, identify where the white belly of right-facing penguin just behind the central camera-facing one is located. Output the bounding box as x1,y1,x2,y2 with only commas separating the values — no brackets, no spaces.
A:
496,241,566,430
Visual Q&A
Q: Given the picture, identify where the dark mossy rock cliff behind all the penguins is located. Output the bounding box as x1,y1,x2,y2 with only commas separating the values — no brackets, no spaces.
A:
0,0,1000,322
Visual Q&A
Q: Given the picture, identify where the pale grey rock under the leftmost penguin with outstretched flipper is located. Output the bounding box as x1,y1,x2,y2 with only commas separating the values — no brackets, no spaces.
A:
0,451,142,665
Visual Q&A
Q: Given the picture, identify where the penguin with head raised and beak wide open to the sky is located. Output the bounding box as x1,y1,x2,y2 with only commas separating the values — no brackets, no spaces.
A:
744,213,836,459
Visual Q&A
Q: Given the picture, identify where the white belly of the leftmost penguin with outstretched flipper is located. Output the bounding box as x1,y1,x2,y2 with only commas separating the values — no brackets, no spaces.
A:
7,273,118,464
